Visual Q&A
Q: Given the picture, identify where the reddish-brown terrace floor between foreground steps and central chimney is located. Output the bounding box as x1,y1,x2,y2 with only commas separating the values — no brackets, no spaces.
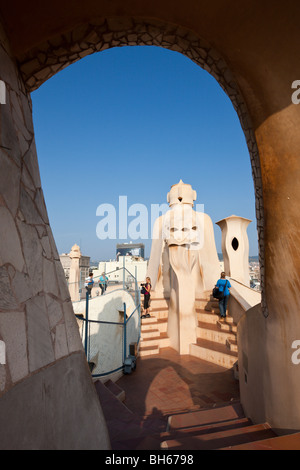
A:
117,348,239,416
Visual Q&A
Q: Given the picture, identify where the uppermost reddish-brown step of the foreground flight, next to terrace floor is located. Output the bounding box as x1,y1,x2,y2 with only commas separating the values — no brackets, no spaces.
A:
167,401,245,431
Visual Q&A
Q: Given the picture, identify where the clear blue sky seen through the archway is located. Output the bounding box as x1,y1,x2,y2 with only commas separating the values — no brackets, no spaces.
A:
32,46,258,260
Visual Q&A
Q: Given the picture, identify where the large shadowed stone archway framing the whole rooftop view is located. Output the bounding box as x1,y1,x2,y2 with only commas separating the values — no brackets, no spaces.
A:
0,0,300,449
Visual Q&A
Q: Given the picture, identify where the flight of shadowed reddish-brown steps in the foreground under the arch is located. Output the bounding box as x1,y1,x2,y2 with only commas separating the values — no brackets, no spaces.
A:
95,377,300,452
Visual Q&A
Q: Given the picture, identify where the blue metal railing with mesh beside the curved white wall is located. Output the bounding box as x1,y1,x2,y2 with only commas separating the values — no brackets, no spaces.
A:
75,267,141,378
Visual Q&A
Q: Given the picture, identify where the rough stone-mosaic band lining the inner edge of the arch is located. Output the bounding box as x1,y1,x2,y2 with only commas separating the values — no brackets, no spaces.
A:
20,18,268,317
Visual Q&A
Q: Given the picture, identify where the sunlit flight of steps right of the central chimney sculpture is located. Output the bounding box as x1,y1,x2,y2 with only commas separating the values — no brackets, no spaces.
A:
190,293,238,378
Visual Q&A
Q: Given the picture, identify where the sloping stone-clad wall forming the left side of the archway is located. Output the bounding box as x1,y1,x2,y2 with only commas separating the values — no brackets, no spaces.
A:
0,21,110,449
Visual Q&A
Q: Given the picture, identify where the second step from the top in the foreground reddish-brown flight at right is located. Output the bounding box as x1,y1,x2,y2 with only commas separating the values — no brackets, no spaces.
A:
161,423,276,451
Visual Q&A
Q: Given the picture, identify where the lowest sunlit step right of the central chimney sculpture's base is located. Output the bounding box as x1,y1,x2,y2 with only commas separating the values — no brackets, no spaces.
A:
190,339,237,369
